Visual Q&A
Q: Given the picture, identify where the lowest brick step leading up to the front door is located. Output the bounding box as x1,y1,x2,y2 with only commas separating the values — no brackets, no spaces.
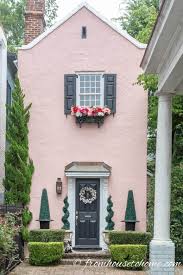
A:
60,258,110,266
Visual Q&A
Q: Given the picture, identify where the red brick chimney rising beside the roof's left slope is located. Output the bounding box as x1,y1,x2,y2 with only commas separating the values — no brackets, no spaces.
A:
25,0,45,44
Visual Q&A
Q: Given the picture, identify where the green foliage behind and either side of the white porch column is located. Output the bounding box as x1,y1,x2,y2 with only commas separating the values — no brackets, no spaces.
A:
138,75,183,262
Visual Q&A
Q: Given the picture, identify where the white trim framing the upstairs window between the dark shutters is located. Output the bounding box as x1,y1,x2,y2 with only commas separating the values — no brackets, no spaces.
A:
76,71,104,107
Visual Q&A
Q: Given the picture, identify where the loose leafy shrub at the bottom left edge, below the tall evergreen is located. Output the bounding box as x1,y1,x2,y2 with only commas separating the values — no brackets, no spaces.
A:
0,214,19,272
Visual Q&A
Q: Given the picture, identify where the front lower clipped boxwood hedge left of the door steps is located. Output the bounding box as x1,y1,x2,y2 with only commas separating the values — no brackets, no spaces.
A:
28,242,64,265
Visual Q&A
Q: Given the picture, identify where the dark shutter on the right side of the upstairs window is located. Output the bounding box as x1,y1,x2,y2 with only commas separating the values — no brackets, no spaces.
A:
104,74,116,114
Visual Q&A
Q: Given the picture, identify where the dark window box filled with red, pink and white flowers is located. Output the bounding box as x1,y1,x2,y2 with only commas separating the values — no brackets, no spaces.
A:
71,106,111,128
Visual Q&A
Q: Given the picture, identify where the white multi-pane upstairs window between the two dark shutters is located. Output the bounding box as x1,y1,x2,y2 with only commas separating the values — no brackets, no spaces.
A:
76,73,104,107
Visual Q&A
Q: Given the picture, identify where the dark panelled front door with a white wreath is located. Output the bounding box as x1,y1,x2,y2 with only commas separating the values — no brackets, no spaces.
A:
76,179,100,246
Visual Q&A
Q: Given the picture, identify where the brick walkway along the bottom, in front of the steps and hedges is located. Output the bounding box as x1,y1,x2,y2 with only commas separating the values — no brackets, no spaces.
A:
10,263,183,275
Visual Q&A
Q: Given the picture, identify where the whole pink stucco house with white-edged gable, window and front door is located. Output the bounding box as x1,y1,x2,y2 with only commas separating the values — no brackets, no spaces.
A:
18,0,147,248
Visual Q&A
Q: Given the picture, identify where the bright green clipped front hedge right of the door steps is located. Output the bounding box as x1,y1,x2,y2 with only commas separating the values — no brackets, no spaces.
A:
110,244,147,270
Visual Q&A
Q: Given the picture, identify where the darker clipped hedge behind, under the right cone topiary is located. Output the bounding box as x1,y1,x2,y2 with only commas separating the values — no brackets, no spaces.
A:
109,231,152,245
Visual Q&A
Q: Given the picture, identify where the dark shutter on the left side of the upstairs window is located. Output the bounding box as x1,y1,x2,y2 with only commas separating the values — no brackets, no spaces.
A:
64,74,77,114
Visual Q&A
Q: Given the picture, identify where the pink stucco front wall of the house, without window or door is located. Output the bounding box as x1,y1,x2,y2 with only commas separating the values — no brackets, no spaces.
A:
18,8,147,230
